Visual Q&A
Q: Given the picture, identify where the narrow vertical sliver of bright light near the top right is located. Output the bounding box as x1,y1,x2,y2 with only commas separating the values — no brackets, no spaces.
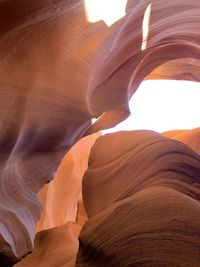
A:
141,4,151,50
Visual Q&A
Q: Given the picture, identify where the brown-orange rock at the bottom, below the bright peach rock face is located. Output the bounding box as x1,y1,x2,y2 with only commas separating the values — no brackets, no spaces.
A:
14,222,81,267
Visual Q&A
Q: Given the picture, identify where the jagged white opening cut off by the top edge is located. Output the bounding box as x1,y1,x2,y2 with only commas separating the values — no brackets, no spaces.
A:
84,0,127,26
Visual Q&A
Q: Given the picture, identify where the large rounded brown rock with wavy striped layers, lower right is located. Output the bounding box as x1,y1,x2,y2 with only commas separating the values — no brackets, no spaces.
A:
76,131,200,267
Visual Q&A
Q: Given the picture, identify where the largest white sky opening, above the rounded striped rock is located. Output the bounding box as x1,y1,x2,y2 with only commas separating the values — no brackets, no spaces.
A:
103,80,200,134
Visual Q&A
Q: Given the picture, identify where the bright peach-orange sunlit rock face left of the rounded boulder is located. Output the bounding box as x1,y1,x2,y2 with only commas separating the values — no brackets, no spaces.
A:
37,133,100,231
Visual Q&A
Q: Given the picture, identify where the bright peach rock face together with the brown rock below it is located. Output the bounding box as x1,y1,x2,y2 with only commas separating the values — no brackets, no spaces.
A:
15,134,99,267
